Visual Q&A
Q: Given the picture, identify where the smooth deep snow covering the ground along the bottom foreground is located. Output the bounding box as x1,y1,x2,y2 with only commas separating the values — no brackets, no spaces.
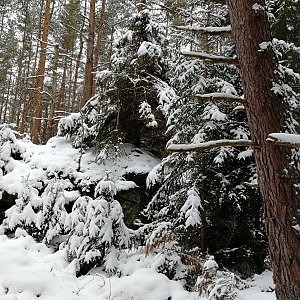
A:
0,231,275,300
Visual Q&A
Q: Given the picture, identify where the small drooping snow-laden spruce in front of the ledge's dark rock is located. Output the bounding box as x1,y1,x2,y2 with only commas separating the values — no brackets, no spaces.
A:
62,179,132,275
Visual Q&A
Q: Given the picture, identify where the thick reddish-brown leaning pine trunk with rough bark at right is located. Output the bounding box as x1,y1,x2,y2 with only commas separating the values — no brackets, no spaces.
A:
228,0,300,300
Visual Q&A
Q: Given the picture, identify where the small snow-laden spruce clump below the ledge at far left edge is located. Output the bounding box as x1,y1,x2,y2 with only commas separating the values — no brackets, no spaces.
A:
2,176,67,244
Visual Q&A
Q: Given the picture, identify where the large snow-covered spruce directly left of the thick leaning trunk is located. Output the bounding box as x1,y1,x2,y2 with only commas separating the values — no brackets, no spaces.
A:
145,1,266,282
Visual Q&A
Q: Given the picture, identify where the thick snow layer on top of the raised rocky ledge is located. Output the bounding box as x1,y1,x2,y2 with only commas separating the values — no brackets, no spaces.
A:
0,137,159,200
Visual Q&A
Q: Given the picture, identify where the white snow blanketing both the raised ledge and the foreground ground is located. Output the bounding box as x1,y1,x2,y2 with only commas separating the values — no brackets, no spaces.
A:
0,132,275,300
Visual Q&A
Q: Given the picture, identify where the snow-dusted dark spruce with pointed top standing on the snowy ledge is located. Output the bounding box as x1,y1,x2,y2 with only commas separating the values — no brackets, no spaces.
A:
59,3,170,156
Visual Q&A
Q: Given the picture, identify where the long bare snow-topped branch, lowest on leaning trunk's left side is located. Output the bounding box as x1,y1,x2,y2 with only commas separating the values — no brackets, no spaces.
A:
167,139,256,152
